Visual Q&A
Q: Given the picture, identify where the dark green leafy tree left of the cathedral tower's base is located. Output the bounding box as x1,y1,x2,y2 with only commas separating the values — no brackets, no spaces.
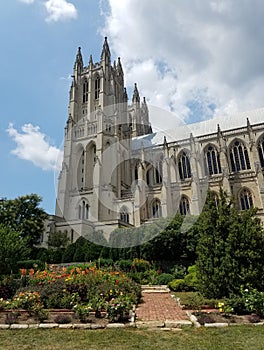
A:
0,194,48,247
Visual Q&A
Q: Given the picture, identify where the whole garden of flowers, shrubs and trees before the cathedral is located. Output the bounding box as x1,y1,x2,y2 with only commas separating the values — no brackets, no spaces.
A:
0,190,264,330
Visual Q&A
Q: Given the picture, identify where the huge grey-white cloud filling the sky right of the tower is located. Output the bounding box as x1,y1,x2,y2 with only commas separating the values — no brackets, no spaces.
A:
101,0,264,127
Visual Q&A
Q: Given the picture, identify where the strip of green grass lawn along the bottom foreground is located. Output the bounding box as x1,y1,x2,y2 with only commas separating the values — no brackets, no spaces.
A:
0,326,264,350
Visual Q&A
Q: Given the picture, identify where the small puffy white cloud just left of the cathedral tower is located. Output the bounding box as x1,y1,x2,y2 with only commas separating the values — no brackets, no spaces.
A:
7,124,62,170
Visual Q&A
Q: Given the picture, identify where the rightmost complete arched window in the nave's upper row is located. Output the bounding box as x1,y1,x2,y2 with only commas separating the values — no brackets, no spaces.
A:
229,141,250,172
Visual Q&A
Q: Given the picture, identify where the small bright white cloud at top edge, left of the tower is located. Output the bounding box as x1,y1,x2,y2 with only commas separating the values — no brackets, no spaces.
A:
45,0,77,22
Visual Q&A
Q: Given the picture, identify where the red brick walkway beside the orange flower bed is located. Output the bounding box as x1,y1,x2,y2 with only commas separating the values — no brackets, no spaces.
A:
136,292,189,321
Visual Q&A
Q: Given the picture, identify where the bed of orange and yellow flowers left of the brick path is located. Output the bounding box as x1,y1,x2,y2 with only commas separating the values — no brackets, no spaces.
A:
0,265,141,323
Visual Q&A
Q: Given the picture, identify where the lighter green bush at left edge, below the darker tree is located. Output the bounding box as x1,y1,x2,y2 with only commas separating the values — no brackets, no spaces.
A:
0,225,30,274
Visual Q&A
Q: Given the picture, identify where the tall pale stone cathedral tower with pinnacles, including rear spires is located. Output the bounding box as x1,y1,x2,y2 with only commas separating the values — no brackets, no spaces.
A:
56,38,151,237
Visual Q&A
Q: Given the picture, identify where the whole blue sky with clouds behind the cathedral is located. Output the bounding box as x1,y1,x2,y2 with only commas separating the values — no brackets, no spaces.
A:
0,0,264,214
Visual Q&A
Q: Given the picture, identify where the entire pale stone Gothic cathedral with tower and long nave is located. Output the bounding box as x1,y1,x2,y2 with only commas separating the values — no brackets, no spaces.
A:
46,38,264,242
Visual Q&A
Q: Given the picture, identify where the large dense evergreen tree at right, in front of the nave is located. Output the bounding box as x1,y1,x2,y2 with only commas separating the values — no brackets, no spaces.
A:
196,190,264,298
